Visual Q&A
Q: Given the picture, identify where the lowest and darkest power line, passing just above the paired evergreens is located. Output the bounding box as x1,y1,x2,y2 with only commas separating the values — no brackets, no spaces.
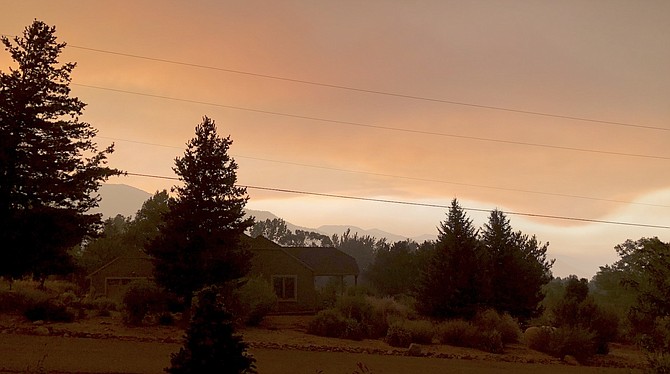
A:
126,172,670,229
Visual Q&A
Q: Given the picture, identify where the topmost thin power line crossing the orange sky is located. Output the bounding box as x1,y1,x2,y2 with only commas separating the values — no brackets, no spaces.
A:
63,45,670,131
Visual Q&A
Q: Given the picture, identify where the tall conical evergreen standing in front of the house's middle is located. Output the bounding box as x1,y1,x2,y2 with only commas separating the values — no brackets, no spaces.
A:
146,117,253,303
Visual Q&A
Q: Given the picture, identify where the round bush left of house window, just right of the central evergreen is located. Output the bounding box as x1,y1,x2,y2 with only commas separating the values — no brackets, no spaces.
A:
231,278,277,326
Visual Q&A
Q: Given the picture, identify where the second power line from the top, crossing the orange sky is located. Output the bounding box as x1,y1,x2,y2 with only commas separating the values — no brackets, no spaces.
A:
80,83,670,160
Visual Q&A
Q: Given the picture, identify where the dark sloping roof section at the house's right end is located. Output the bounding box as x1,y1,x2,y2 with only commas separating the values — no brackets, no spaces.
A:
282,247,359,275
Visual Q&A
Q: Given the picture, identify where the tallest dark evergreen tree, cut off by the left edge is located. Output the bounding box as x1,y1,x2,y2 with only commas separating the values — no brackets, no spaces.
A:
0,20,120,279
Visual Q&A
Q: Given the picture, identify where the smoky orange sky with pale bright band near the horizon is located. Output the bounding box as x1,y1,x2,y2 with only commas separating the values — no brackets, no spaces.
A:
0,0,670,278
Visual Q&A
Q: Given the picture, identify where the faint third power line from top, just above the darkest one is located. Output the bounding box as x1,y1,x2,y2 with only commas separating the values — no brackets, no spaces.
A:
98,136,670,212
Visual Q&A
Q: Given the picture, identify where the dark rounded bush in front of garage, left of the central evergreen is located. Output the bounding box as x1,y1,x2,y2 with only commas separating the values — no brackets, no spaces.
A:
123,280,165,325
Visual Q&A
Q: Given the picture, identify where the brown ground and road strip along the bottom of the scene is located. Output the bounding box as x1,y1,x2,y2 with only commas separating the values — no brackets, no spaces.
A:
0,314,642,374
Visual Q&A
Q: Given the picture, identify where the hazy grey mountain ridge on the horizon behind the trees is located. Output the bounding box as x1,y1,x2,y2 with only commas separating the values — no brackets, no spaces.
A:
93,184,435,243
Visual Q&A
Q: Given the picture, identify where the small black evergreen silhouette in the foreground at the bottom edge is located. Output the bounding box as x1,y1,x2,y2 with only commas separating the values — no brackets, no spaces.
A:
165,286,256,374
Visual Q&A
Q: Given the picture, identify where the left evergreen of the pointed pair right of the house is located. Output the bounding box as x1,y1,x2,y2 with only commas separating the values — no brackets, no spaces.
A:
417,199,486,318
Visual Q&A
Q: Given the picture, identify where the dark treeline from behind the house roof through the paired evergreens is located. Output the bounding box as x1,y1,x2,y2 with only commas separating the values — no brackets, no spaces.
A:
251,199,553,319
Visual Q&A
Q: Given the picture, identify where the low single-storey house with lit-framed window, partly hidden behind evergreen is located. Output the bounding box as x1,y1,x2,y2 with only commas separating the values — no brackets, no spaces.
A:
89,235,359,313
